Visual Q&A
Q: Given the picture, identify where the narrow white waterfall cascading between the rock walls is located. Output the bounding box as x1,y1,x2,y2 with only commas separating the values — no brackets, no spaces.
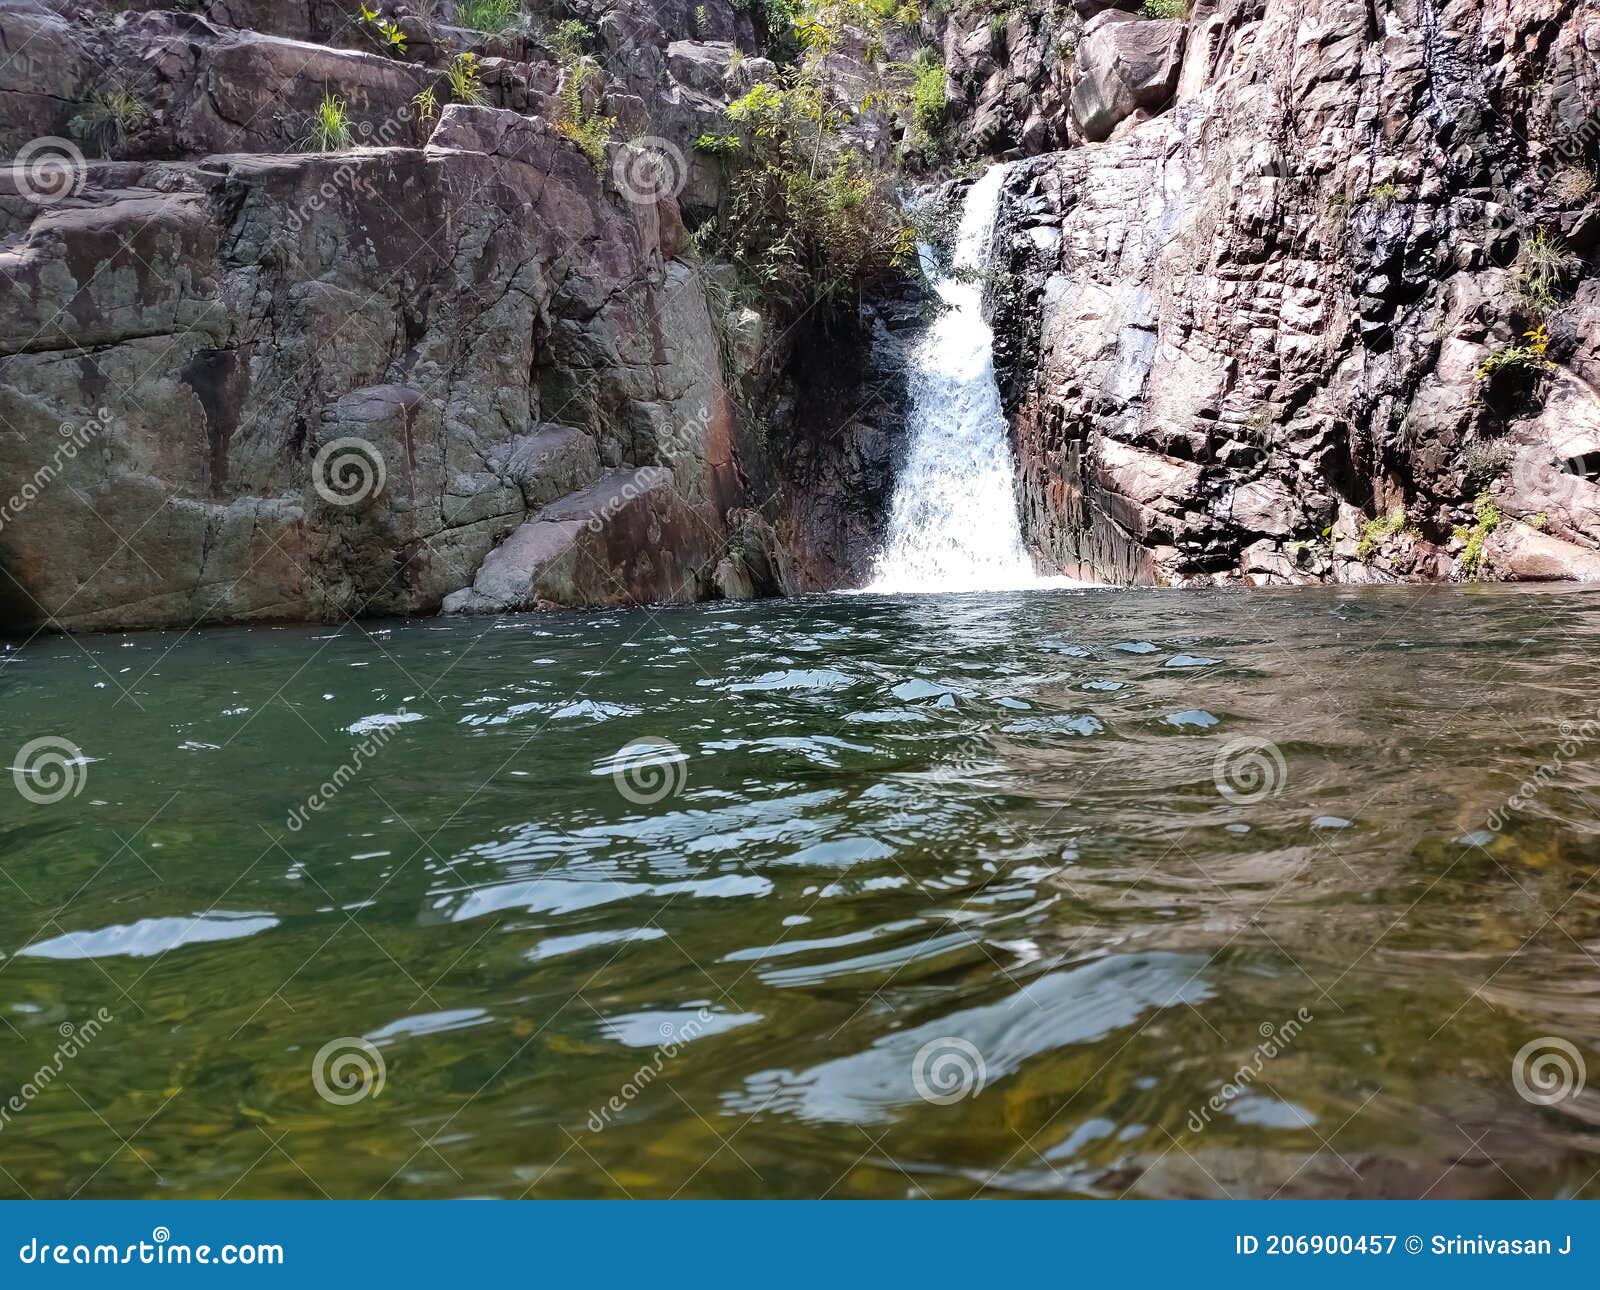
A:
867,165,1043,592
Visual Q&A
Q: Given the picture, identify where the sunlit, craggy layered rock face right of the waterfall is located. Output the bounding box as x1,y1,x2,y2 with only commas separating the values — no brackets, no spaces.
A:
990,0,1600,584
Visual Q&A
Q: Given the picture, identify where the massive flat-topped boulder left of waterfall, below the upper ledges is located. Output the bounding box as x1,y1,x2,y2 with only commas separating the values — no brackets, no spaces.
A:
0,90,742,627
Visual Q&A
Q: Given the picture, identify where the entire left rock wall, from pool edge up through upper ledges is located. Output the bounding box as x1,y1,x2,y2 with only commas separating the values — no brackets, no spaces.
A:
0,0,825,631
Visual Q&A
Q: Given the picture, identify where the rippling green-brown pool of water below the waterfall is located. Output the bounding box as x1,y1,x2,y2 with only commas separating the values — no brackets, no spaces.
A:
0,587,1600,1197
